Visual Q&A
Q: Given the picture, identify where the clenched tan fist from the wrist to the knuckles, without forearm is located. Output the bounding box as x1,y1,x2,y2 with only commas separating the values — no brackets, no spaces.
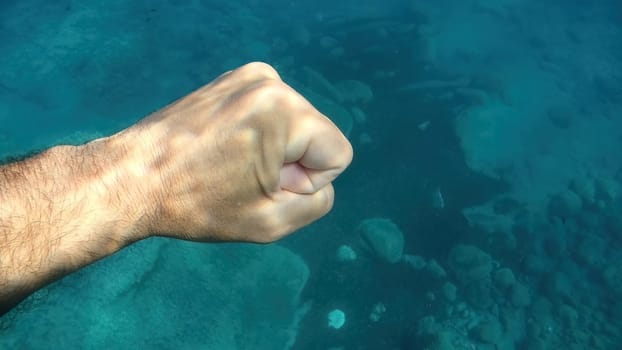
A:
105,63,352,243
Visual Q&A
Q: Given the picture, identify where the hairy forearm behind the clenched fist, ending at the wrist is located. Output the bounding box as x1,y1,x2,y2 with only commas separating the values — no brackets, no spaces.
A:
0,139,144,314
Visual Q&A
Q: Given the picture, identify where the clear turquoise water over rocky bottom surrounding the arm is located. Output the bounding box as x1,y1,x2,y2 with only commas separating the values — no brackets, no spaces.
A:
0,0,622,350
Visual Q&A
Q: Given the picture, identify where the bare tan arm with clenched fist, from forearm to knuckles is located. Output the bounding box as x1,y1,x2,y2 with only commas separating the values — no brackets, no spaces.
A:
0,63,352,314
